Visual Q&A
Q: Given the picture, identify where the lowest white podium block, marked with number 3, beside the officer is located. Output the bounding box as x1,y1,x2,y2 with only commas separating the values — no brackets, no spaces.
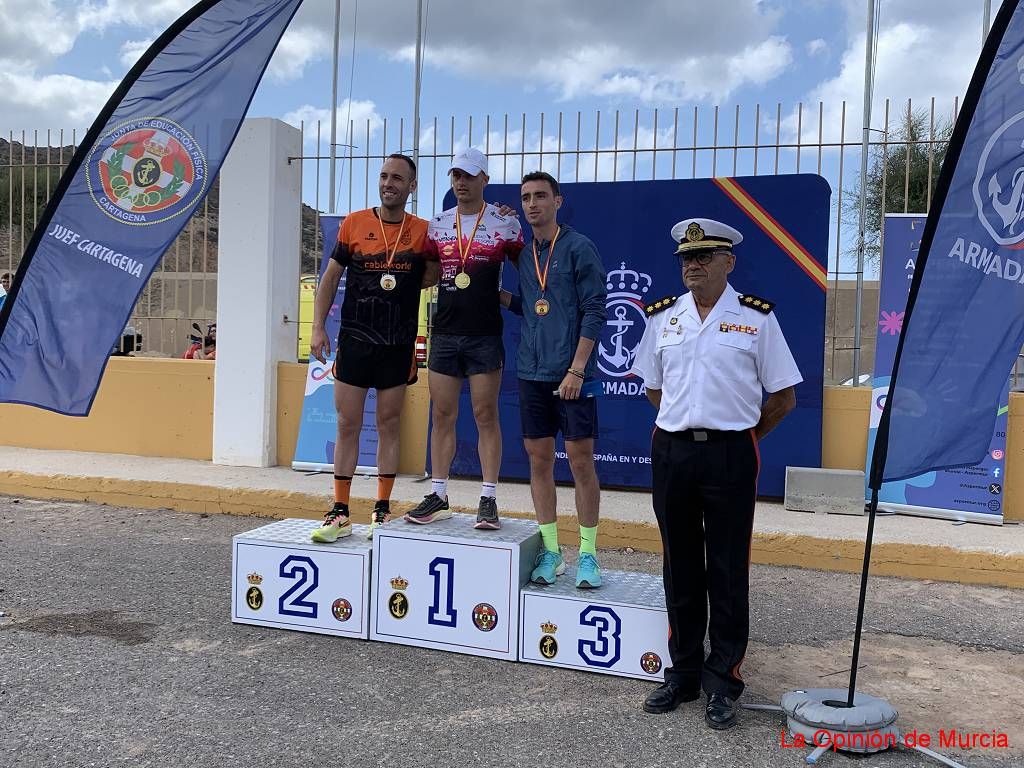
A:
519,568,671,680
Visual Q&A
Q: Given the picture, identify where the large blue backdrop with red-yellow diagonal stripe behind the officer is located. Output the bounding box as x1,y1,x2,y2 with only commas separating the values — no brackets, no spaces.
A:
444,174,830,497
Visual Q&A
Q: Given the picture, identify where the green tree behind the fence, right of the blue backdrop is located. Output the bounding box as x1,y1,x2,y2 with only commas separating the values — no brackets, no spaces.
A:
843,110,952,266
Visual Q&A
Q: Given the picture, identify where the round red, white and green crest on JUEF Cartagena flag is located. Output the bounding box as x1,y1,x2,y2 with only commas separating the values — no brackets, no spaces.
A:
86,118,207,226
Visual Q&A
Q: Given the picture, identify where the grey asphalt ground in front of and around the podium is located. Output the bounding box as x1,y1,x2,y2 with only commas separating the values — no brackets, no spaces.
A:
0,497,1024,768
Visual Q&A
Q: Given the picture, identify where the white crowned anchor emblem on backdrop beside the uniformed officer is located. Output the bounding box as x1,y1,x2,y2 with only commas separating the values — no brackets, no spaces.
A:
597,261,653,379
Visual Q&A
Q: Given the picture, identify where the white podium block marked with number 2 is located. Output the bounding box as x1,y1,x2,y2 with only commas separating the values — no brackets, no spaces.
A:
231,519,371,639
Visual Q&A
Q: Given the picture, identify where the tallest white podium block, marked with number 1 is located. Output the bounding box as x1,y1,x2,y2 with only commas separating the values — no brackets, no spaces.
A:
370,515,540,660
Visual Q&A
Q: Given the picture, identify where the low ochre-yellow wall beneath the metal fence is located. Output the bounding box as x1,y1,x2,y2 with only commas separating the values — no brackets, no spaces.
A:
0,357,1024,520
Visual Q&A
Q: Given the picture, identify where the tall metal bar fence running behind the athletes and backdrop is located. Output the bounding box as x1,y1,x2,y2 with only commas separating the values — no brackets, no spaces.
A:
0,99,958,384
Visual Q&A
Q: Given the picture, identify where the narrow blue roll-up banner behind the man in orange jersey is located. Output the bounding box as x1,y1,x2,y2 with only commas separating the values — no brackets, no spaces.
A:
292,216,377,474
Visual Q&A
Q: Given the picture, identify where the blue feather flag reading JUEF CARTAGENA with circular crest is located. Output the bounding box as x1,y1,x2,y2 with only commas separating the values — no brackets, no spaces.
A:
0,0,301,416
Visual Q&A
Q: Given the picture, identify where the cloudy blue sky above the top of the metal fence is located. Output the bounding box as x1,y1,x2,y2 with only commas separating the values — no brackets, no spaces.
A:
0,0,998,217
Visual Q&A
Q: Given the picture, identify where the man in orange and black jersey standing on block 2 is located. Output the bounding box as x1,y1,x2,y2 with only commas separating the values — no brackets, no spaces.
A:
309,155,438,543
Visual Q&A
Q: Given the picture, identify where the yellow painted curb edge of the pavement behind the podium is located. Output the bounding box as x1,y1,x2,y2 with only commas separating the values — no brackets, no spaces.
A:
0,471,1024,589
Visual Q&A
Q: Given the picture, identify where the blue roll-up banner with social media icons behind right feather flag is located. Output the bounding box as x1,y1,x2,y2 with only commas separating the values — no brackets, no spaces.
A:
865,214,1010,523
